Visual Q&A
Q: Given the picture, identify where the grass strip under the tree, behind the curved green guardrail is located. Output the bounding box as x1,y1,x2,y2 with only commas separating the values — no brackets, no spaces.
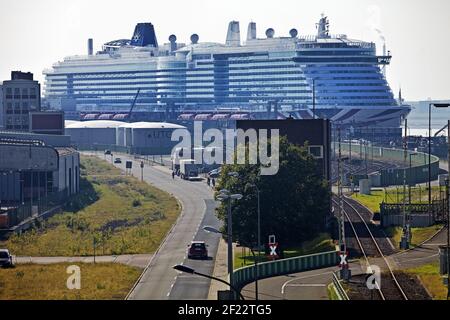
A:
234,233,335,269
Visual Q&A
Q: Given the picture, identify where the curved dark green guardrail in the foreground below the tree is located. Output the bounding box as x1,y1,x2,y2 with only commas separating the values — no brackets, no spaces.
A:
233,251,339,291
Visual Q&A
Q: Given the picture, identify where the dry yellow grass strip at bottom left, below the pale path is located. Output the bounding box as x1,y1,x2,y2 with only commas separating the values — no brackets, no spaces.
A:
0,263,141,300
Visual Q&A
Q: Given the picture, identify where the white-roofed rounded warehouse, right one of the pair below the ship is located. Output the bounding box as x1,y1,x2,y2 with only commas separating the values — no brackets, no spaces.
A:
117,122,186,155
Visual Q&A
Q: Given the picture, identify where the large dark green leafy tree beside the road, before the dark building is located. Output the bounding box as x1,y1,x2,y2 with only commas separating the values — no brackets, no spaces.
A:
217,137,330,247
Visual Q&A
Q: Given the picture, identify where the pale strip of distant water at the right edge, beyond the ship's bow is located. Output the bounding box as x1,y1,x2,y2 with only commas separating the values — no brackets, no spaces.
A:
408,102,450,136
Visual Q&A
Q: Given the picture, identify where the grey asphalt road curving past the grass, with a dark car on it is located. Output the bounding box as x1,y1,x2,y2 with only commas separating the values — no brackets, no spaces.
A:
89,154,220,300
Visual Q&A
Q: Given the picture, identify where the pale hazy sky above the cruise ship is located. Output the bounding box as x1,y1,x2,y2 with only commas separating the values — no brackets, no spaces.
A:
0,0,450,100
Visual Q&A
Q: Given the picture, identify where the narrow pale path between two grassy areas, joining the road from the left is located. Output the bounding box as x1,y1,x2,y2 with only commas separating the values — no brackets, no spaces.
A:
15,254,153,269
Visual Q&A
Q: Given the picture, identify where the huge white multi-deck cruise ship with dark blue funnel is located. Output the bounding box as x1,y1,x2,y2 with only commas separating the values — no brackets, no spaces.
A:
44,16,410,128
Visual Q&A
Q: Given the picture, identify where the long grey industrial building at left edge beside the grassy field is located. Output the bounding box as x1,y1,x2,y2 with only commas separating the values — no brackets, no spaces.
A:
0,131,80,234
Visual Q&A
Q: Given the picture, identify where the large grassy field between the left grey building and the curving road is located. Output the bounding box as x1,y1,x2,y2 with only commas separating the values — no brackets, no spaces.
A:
0,156,180,256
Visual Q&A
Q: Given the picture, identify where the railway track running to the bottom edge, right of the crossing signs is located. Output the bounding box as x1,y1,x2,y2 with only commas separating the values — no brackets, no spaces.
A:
333,198,408,300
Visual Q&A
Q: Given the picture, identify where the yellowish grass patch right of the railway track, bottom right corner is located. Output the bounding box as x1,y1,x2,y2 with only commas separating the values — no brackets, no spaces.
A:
405,262,447,300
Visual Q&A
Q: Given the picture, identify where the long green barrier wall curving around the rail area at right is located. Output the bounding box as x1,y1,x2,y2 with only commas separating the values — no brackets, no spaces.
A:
335,143,439,187
